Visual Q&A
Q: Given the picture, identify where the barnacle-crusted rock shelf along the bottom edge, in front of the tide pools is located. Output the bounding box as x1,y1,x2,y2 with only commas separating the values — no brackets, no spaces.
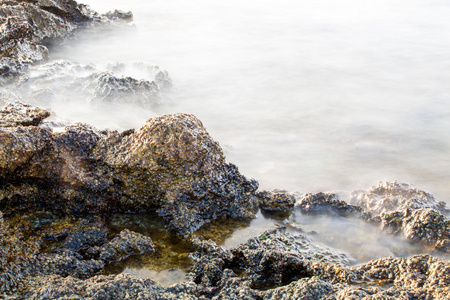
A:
0,214,450,300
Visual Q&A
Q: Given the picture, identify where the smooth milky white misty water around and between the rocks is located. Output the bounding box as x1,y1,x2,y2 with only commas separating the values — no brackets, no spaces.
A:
5,0,450,281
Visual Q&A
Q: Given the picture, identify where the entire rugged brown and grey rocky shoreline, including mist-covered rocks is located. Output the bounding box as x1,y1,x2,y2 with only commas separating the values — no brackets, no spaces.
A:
0,0,450,299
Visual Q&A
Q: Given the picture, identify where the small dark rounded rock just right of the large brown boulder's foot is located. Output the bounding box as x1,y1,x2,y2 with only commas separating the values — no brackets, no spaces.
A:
256,190,295,212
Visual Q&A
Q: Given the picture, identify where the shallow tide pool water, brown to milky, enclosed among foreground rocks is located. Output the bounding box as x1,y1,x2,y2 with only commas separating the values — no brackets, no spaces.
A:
104,207,442,286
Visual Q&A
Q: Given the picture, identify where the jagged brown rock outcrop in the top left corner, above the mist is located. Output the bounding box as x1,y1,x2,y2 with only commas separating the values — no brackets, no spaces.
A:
0,0,131,75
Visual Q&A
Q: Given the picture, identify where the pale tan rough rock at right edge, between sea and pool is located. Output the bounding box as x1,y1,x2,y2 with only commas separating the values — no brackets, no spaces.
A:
351,182,450,253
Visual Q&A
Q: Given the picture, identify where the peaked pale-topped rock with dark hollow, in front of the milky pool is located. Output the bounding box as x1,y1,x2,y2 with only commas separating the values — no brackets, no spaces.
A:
231,228,353,287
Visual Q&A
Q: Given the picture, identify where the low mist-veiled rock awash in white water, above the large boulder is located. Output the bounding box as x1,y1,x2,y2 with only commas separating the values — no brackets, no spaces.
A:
8,60,172,109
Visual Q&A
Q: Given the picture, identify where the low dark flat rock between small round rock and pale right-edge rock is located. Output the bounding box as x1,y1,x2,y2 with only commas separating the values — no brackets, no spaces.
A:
296,193,363,216
